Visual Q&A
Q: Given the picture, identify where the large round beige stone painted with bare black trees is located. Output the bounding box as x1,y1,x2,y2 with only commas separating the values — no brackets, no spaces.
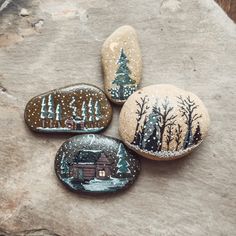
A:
119,85,210,160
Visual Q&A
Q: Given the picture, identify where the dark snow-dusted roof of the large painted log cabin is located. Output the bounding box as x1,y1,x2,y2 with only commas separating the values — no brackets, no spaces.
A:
73,150,102,163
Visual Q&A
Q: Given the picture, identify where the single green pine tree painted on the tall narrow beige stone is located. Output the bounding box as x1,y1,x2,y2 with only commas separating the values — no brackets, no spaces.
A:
112,48,135,100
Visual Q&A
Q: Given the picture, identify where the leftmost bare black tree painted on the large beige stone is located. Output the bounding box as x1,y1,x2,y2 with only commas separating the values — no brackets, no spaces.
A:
132,96,149,145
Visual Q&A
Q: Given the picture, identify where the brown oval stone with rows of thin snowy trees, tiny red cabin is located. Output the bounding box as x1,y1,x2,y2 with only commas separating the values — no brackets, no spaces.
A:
25,84,112,133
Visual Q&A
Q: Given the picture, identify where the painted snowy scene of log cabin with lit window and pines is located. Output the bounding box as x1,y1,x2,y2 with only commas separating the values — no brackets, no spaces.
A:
58,139,138,192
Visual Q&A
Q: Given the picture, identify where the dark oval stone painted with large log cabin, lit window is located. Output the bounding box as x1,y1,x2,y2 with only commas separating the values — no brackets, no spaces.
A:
55,134,140,193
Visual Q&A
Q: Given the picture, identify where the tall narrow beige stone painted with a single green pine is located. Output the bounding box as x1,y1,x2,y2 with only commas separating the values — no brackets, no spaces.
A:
102,25,142,104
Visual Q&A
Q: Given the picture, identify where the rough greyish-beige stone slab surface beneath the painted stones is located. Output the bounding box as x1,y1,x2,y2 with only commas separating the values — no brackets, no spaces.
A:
0,0,236,236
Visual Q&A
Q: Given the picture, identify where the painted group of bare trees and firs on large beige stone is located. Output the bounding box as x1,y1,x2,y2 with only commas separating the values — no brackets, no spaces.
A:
131,96,202,157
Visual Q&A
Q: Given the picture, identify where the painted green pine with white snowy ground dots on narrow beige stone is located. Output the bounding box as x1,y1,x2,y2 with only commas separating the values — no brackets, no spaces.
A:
109,48,137,100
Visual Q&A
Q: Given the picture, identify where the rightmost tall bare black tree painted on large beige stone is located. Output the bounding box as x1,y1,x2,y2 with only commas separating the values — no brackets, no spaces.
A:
177,96,202,149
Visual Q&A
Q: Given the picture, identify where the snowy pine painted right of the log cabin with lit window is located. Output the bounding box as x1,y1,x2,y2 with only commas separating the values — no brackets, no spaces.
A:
117,143,131,175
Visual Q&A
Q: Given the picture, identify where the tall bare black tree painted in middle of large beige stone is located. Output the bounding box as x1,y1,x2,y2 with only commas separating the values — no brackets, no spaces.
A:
153,97,177,151
